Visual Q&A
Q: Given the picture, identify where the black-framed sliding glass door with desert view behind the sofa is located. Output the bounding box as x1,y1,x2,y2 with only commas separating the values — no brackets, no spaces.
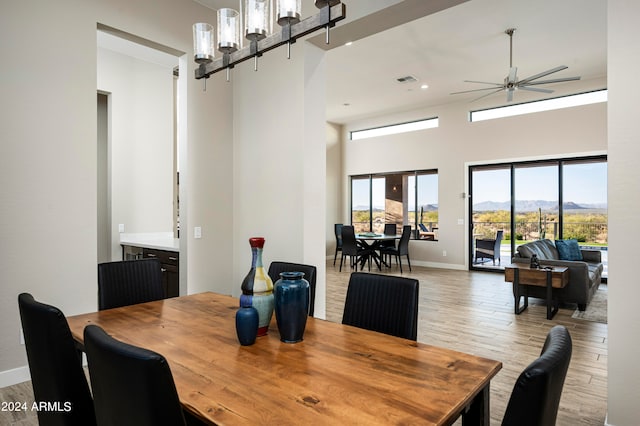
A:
469,156,608,277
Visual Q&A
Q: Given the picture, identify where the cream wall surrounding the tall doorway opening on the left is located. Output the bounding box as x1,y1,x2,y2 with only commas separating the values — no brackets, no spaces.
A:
0,0,232,386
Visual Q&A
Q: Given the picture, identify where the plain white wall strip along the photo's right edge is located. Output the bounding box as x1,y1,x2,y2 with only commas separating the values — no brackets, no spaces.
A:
607,0,640,426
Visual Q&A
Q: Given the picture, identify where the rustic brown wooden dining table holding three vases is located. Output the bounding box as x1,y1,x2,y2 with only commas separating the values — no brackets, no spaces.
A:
67,292,502,425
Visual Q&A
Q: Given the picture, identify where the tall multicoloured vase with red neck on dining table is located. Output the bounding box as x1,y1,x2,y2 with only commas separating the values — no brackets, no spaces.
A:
240,237,273,337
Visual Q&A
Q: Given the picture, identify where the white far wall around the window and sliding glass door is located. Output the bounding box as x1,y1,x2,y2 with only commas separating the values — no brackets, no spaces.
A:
338,81,607,269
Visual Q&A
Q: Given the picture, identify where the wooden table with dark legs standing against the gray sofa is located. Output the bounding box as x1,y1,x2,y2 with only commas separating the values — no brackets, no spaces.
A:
504,263,569,319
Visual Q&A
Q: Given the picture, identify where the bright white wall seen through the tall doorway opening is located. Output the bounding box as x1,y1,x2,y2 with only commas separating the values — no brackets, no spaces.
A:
97,48,178,260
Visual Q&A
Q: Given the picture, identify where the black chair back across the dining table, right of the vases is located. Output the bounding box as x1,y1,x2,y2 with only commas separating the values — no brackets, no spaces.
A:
342,272,420,340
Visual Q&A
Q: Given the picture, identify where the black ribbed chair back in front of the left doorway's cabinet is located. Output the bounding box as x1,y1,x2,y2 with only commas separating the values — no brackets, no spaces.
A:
98,259,166,310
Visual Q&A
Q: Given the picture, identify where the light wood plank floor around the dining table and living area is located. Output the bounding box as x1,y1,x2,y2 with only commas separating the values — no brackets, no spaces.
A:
0,260,607,426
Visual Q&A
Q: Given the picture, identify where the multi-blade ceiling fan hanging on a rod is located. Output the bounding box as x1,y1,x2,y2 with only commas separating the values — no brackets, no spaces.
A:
450,28,580,102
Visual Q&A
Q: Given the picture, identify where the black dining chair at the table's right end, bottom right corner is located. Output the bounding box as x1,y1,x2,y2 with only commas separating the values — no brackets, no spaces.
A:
502,325,572,426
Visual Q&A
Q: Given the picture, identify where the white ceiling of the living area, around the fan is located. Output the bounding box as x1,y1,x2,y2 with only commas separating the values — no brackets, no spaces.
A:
327,0,607,123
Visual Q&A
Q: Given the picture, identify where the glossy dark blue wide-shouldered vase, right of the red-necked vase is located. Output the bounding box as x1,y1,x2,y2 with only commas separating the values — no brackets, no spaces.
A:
274,272,309,343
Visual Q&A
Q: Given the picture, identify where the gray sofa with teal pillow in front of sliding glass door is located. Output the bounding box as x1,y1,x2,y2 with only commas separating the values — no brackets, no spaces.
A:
511,240,603,311
